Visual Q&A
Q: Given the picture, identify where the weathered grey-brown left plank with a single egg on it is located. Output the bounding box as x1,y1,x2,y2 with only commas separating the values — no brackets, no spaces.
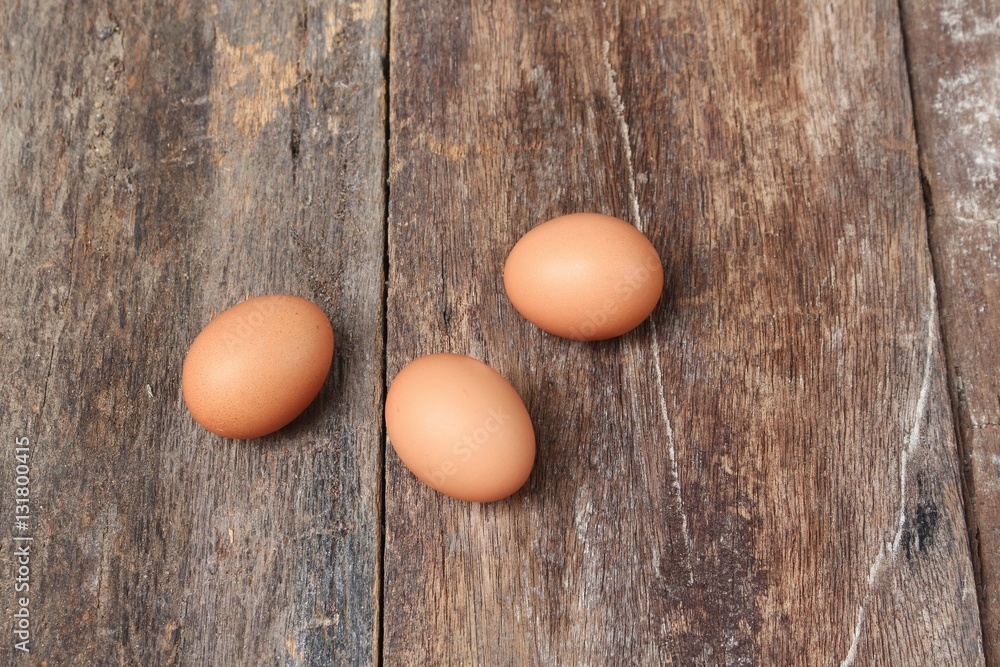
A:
0,0,386,665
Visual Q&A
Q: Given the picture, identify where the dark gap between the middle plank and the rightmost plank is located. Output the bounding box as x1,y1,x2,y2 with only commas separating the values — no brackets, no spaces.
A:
896,0,986,647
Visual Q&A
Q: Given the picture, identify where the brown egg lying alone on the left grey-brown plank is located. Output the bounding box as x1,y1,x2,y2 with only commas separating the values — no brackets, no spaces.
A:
181,294,333,438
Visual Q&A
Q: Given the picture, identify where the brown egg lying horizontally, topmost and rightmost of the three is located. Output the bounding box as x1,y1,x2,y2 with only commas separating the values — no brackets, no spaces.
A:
503,213,663,340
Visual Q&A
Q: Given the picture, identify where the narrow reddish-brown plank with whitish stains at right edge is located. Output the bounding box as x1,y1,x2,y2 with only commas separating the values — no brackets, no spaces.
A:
903,0,1000,665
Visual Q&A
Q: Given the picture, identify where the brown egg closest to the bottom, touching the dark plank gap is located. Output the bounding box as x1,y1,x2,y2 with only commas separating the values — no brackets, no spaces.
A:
385,354,535,503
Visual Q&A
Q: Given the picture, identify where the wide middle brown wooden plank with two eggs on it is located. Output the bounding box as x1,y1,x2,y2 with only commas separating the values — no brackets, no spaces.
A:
384,0,983,665
